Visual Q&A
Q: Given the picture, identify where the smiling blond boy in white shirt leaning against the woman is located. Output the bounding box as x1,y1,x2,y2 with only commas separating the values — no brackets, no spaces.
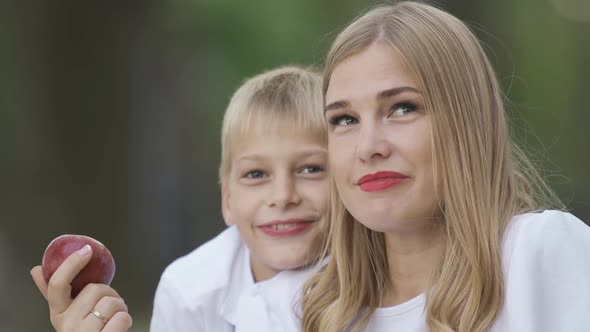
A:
151,67,329,332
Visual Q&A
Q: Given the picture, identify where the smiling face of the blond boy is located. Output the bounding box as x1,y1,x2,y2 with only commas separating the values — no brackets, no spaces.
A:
222,130,329,281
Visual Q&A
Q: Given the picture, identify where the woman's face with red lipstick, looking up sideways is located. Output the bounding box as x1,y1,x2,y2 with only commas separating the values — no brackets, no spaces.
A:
326,43,437,233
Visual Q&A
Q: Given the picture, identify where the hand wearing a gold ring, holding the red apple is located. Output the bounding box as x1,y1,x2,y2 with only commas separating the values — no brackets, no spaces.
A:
31,246,132,332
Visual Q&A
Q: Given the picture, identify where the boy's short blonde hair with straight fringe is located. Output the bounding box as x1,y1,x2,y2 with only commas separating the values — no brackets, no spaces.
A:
219,66,327,183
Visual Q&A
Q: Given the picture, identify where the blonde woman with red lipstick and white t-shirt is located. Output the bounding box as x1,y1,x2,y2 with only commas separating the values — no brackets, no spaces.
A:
298,2,590,332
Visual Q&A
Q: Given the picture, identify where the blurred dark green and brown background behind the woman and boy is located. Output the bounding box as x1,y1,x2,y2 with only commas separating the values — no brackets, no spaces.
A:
0,0,590,332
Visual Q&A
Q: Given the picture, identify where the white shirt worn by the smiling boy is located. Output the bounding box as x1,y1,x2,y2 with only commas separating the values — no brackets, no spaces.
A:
150,227,299,332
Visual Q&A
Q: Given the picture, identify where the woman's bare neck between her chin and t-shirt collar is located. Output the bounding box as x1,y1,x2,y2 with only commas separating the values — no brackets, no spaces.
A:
381,227,444,307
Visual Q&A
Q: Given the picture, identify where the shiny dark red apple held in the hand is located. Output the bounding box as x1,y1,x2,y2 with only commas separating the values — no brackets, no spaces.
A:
41,234,115,298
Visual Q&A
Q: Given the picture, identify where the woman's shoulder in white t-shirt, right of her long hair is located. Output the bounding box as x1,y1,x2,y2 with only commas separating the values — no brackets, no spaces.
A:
492,211,590,331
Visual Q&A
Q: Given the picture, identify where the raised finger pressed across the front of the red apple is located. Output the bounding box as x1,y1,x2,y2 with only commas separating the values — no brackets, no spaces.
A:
47,245,92,316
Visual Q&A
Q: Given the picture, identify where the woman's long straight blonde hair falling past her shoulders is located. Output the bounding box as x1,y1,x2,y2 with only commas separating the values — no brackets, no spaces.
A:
302,2,561,332
